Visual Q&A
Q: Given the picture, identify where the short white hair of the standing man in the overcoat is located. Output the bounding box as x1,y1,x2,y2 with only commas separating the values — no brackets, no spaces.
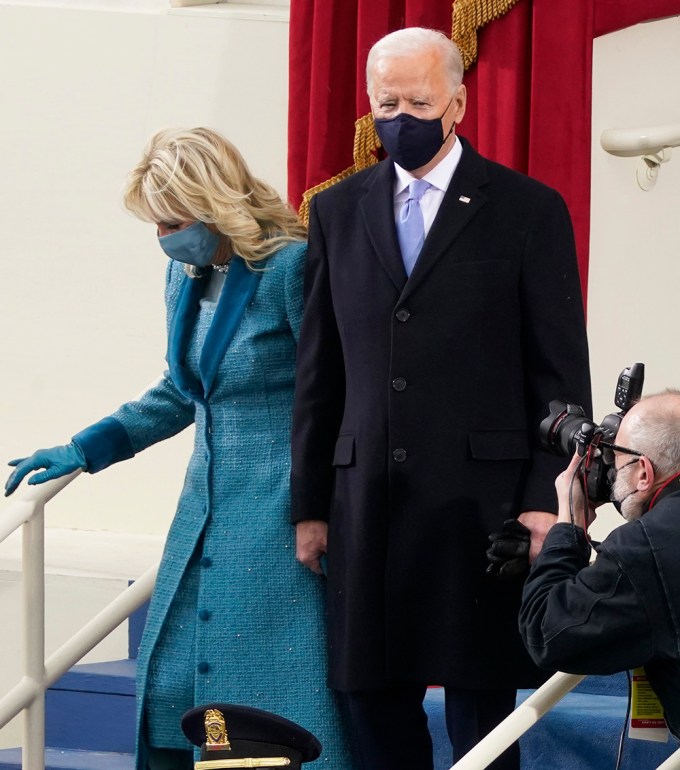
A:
366,27,465,95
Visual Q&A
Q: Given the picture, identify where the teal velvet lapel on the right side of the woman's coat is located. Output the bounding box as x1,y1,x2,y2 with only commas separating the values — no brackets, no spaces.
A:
198,256,262,398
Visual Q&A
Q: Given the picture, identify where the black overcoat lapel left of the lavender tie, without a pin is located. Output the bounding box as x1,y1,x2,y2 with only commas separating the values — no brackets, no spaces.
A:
359,160,406,292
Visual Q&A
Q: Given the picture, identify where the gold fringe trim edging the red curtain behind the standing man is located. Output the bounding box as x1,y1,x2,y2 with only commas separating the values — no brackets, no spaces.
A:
298,0,518,226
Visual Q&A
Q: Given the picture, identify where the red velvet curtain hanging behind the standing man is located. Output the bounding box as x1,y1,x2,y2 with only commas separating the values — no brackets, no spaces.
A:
288,0,680,296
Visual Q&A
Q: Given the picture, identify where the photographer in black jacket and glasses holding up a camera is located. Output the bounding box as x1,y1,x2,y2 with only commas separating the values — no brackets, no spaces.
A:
520,390,680,737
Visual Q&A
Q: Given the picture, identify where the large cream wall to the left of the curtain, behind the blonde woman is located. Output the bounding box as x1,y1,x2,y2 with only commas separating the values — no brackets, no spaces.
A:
0,0,288,533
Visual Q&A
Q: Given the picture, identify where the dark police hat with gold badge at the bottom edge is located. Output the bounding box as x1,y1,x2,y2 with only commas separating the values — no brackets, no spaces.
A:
182,703,321,770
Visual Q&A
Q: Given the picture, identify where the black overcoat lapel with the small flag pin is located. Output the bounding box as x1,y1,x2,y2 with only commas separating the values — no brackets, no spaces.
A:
393,139,488,300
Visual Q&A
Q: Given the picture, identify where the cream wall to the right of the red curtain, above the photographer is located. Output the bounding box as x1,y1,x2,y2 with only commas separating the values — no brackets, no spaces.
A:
588,17,680,533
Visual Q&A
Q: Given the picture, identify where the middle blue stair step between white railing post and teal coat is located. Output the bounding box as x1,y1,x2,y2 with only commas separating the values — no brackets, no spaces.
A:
46,660,136,752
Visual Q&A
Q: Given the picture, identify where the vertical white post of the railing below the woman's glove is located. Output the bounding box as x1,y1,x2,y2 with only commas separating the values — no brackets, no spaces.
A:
21,504,45,770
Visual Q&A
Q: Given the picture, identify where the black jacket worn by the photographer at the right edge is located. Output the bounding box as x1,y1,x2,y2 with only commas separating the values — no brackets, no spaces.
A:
520,478,680,736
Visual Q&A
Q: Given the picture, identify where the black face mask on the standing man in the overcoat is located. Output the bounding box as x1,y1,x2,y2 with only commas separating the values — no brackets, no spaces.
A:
374,97,456,171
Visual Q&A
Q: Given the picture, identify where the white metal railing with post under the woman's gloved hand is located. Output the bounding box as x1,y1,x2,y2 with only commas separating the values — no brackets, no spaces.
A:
0,471,158,770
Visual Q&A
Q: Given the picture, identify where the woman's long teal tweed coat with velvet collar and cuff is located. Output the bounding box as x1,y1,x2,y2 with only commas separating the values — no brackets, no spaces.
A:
74,243,352,770
